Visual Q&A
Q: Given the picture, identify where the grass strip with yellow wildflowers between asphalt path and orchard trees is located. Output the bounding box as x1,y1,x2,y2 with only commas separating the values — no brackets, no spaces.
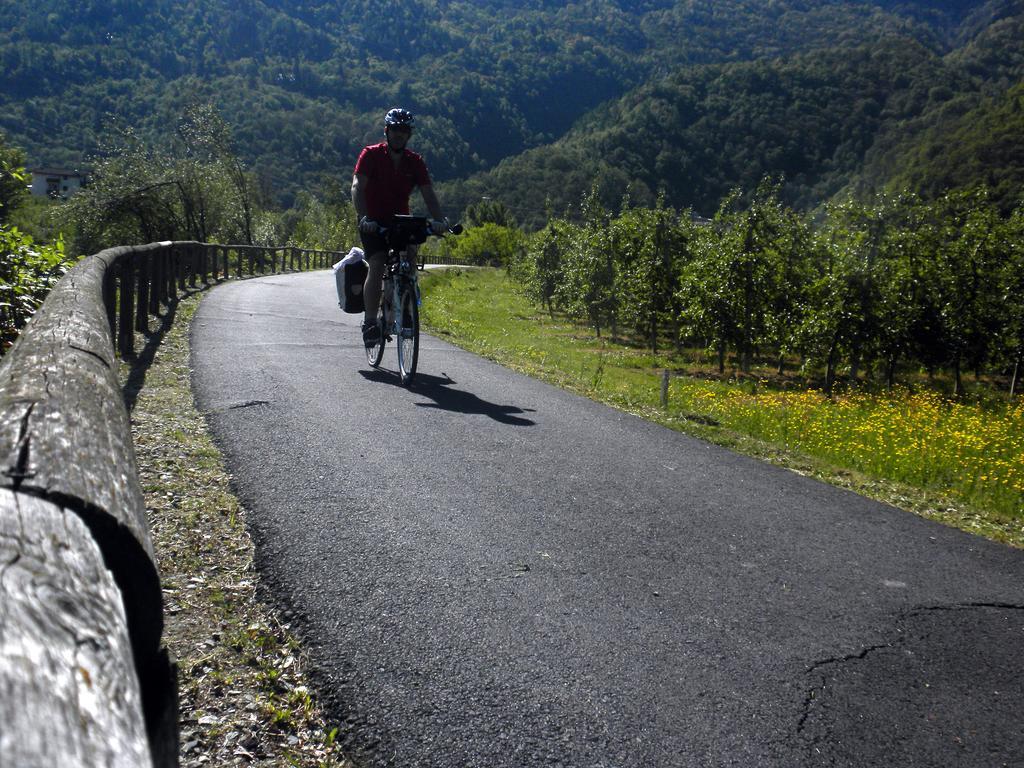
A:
423,269,1024,547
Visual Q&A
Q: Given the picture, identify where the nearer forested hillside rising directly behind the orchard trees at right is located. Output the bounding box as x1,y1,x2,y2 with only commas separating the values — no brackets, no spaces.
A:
445,6,1024,224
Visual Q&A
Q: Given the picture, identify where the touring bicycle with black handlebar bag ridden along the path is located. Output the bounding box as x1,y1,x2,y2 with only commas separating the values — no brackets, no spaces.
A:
366,215,462,386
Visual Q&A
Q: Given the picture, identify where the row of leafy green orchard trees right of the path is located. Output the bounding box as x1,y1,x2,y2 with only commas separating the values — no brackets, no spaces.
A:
510,180,1024,394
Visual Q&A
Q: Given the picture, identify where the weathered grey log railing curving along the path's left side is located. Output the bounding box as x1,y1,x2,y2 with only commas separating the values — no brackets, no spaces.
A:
0,243,341,768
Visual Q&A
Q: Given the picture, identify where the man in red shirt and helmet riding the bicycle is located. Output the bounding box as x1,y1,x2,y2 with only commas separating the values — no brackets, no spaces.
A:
352,106,447,346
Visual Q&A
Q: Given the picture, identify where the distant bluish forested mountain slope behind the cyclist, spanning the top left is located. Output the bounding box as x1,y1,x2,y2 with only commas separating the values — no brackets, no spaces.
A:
0,0,984,204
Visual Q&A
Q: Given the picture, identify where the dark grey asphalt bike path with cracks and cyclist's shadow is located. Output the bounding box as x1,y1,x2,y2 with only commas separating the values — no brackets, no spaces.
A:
193,272,1024,768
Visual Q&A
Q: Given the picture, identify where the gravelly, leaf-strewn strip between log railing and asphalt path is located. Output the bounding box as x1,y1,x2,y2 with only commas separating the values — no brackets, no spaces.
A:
122,293,353,768
